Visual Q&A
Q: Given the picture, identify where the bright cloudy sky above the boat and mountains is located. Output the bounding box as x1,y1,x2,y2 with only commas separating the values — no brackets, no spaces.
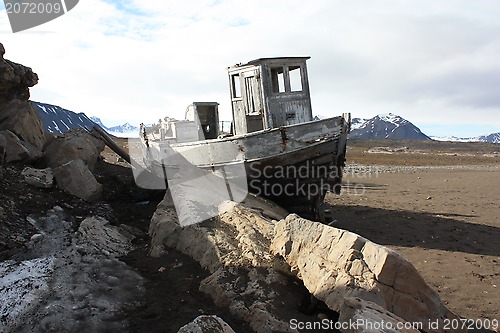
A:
0,0,500,136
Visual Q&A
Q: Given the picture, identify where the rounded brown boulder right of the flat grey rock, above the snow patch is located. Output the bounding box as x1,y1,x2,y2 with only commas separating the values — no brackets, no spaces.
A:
54,160,102,202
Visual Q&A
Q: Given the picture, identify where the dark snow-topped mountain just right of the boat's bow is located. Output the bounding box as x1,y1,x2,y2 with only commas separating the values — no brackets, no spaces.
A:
349,113,431,140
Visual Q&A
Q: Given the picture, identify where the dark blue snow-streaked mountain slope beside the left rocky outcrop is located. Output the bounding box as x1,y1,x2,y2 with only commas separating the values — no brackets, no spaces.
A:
31,102,94,134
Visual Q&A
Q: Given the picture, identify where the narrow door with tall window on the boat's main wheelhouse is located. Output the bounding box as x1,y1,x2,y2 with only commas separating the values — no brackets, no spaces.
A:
241,69,264,133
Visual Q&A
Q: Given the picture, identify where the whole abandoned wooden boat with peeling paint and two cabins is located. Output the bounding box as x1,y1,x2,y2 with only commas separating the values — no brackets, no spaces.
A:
141,57,350,220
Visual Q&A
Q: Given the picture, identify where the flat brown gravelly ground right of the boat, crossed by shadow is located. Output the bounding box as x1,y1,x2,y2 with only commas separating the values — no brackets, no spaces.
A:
327,140,500,320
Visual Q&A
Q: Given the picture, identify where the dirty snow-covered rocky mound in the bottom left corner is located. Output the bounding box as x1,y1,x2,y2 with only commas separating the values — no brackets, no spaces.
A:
0,207,144,332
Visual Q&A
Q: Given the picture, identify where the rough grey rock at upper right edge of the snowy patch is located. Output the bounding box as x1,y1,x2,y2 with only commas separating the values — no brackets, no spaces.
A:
77,217,135,257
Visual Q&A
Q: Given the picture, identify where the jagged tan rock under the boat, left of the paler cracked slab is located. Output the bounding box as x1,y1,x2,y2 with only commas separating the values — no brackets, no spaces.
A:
149,191,287,272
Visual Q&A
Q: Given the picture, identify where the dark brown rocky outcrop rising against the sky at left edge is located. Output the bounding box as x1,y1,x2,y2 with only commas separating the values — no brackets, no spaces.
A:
0,44,45,150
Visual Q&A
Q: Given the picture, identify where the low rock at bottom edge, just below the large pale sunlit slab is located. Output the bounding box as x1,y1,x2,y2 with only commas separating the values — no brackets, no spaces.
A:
337,298,420,333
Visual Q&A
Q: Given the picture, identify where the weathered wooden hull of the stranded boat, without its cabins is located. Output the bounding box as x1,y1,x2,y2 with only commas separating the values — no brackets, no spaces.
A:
143,117,349,220
